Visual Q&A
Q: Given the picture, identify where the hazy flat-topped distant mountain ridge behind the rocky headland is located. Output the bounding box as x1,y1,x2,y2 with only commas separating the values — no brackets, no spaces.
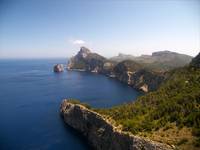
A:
110,51,192,71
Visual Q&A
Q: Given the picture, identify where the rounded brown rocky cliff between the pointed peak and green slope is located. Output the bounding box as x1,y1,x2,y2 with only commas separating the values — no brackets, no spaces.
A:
113,60,165,92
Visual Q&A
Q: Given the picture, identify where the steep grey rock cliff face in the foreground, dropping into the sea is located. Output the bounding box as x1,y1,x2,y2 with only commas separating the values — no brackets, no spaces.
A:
60,100,172,150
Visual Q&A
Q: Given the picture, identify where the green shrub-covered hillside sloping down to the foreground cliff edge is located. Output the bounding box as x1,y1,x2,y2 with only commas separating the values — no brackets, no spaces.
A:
96,67,200,149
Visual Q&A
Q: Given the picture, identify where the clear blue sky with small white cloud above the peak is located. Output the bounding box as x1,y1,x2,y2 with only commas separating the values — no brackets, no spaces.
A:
0,0,200,58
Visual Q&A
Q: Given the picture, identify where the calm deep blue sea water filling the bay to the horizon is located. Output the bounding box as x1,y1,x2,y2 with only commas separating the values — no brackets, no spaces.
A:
0,59,140,150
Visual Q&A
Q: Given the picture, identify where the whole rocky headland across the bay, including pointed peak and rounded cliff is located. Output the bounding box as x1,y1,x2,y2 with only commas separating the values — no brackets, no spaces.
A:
68,47,165,92
